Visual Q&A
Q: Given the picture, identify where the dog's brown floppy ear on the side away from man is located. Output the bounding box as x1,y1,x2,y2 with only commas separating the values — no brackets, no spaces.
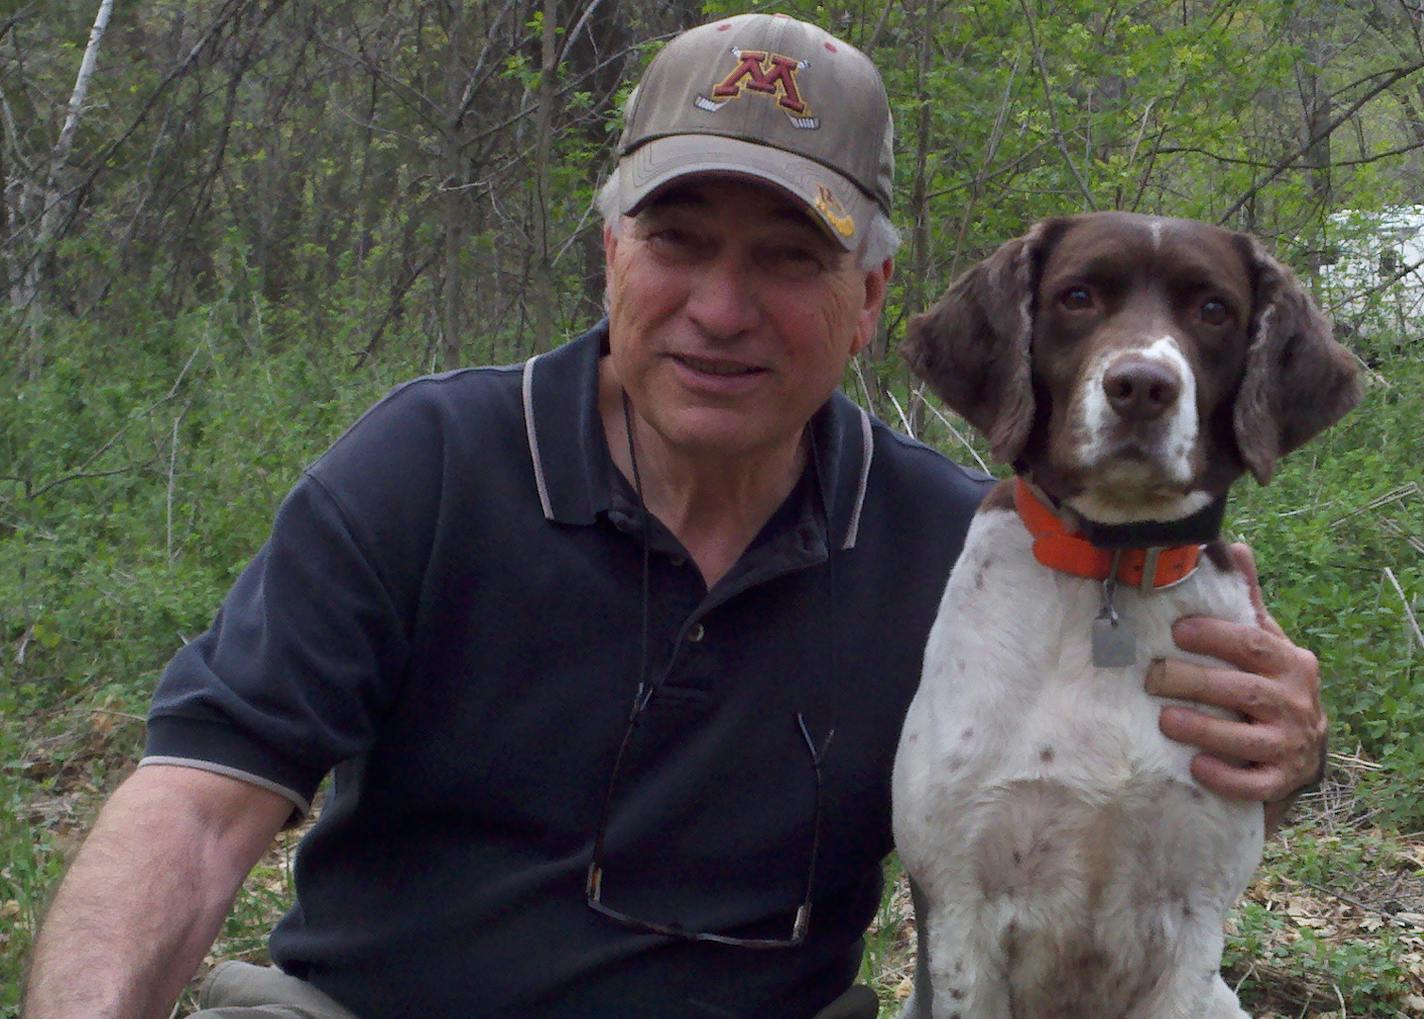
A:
1233,235,1360,484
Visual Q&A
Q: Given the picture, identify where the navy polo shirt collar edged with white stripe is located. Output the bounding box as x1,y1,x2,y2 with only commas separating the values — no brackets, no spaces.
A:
523,319,874,549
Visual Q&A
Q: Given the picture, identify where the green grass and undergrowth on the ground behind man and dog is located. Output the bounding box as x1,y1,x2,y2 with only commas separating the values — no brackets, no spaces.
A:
0,320,1424,1019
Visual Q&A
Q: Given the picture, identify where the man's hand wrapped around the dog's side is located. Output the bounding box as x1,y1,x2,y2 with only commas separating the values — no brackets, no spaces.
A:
1146,545,1326,827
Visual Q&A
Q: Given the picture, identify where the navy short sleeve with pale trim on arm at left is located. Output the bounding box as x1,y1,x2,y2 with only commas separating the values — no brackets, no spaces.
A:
142,466,410,813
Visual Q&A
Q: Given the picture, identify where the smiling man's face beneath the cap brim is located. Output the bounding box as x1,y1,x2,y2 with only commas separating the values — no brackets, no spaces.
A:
604,179,890,458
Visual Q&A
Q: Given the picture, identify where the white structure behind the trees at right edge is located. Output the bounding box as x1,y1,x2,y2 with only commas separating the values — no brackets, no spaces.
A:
1320,205,1424,339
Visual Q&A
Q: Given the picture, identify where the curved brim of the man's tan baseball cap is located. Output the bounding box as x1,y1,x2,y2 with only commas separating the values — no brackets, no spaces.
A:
618,134,876,250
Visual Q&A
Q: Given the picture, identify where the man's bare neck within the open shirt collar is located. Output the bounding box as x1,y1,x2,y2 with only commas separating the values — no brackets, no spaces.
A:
598,357,807,589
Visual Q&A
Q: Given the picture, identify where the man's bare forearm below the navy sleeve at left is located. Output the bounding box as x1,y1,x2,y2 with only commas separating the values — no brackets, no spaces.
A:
24,764,292,1019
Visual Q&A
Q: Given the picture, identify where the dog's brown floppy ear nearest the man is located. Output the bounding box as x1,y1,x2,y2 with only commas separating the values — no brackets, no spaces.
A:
900,219,1067,464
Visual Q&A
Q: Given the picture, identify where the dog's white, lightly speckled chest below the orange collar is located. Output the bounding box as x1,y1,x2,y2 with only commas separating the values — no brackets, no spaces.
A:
894,510,1260,972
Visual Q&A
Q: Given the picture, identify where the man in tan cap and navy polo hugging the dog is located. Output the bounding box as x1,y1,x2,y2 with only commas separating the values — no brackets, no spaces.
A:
27,16,1324,1019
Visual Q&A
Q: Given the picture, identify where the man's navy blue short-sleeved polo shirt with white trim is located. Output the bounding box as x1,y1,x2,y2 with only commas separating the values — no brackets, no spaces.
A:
145,324,985,1019
